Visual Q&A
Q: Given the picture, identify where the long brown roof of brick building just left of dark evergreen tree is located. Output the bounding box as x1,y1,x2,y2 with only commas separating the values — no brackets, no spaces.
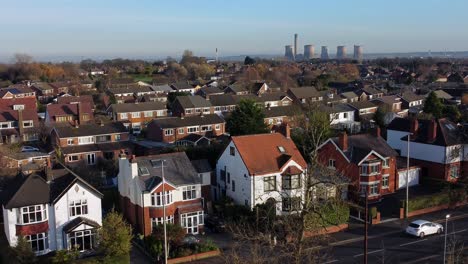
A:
151,114,225,128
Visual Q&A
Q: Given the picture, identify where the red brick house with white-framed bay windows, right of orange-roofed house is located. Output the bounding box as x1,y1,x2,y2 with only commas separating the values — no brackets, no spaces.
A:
319,129,398,200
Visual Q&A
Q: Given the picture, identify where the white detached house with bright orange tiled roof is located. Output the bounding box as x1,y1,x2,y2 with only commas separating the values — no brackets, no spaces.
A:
215,125,307,214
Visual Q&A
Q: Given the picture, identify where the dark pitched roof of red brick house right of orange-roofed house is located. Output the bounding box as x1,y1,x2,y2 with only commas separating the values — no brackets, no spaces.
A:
332,134,398,164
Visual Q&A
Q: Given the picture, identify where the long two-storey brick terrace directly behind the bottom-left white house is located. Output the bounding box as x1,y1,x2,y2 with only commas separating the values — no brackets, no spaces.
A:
51,123,133,166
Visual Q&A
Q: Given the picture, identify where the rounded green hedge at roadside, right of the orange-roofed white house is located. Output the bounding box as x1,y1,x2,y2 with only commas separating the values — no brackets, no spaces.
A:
306,200,349,230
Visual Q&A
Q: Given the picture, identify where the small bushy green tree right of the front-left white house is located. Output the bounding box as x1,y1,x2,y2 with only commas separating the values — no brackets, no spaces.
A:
99,211,132,257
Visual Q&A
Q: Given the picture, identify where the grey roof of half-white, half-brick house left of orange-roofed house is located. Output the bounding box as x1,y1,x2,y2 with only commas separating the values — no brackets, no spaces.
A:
135,152,201,191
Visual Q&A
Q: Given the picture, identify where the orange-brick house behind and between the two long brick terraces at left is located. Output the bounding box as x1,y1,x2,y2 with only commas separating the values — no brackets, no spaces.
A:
107,102,167,132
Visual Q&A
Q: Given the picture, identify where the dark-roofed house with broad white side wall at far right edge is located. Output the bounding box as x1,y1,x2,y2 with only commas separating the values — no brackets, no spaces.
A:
387,118,468,181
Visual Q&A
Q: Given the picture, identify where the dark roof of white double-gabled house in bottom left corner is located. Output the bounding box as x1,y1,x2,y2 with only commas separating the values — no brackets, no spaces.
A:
1,167,102,209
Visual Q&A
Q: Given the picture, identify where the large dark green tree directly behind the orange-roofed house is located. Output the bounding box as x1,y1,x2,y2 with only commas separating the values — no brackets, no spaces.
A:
226,99,268,136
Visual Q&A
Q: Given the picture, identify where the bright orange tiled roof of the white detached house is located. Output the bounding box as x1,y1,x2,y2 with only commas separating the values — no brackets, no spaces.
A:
231,133,307,175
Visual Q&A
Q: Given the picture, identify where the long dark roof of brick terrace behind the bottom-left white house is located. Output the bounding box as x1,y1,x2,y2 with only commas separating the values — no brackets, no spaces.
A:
54,122,128,138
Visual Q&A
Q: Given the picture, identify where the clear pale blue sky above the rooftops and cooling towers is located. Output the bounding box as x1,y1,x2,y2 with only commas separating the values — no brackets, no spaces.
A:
0,0,468,58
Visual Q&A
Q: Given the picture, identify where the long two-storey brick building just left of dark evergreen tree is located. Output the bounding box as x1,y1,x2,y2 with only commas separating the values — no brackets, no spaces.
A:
146,114,226,143
